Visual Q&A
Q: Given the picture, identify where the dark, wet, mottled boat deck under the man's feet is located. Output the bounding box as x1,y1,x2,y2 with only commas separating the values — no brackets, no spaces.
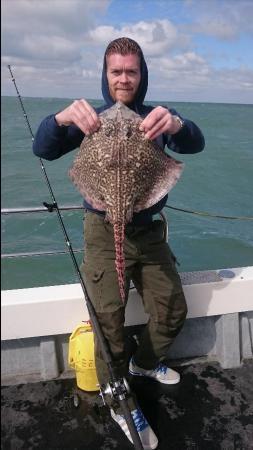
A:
1,360,253,450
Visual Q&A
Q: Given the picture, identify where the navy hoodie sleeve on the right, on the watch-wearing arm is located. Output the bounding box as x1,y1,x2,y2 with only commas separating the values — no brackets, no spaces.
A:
165,109,205,153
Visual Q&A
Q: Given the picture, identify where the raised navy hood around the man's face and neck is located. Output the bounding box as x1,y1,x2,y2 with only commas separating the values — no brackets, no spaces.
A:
102,49,148,112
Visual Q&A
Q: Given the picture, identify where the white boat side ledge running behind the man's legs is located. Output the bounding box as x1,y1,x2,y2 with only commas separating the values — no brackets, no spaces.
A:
1,267,253,340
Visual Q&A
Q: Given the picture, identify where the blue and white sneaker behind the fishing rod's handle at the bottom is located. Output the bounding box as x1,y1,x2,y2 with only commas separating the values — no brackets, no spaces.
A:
110,408,158,450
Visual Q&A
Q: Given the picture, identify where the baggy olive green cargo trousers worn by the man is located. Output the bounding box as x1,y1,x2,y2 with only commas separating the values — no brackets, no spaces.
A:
80,211,187,392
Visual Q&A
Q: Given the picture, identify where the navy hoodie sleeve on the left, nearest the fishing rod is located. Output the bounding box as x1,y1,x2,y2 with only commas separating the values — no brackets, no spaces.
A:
33,114,84,161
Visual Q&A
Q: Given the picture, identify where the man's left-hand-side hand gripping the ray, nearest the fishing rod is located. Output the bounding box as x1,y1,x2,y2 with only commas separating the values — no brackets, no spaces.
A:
55,99,100,135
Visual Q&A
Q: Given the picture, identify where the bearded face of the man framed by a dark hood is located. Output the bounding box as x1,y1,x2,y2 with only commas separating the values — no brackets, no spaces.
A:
106,53,141,105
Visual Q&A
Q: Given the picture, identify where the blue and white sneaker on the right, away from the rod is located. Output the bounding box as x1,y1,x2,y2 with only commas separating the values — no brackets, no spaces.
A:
129,358,180,384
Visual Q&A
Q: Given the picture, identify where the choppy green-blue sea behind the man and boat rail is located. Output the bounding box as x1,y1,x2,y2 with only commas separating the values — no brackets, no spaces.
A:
1,96,253,290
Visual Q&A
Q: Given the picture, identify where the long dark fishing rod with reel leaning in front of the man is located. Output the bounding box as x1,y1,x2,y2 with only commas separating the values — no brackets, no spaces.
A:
8,65,143,450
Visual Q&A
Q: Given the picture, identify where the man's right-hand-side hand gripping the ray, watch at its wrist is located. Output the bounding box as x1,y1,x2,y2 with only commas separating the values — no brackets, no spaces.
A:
140,106,181,140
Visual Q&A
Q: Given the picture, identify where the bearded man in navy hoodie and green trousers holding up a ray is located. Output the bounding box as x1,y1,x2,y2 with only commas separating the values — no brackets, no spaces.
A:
33,38,204,449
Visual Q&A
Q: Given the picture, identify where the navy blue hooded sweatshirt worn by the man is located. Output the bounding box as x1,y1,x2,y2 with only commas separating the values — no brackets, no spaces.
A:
33,49,205,225
